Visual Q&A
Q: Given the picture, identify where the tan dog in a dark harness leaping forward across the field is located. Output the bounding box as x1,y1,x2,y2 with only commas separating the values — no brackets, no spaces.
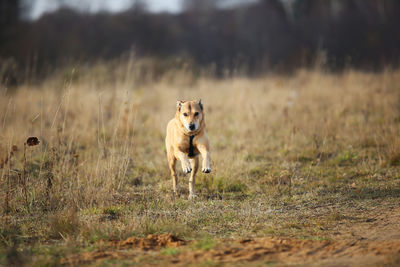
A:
165,100,211,199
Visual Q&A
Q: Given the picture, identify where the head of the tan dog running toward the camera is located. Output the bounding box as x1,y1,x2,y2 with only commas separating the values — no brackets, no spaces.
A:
176,100,204,133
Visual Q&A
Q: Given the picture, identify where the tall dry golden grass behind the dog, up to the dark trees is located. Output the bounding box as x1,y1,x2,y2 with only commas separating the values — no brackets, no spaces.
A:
0,64,400,215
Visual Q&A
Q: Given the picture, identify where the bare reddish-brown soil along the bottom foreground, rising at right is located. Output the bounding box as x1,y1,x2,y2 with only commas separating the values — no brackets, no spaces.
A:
62,207,400,266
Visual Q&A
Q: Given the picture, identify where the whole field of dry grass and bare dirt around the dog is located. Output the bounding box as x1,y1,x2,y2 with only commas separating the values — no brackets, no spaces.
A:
0,64,400,266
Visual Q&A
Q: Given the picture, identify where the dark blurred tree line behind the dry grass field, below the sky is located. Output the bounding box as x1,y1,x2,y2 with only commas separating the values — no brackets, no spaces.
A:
0,0,400,82
